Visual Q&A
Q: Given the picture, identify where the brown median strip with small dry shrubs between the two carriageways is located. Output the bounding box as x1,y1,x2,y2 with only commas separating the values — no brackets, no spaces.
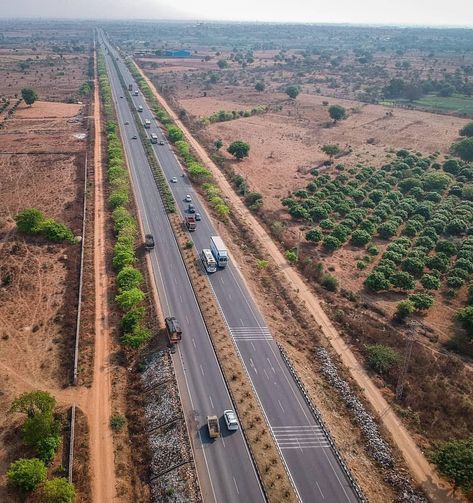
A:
169,215,298,502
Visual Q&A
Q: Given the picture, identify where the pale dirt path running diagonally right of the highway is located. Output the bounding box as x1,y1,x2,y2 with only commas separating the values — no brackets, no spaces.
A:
140,69,458,501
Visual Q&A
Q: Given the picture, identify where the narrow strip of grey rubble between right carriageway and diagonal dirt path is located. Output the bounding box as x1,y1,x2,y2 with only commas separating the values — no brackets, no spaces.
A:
315,348,427,503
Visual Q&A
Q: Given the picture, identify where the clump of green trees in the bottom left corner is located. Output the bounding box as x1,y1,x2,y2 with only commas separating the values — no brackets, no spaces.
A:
7,391,75,503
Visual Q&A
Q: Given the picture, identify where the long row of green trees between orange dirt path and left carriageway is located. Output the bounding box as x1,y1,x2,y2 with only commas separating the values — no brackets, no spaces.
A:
97,53,151,348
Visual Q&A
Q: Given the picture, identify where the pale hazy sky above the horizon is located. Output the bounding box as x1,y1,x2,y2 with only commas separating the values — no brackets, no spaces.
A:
0,0,473,26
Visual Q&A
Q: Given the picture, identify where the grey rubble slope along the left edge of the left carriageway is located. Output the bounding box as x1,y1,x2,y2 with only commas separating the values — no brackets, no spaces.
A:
142,351,201,503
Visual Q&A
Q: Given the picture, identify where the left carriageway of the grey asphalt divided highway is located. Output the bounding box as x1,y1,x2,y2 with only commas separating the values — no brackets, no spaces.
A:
100,36,265,503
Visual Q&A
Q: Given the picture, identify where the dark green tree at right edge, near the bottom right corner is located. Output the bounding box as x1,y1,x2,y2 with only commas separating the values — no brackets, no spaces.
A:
432,437,473,491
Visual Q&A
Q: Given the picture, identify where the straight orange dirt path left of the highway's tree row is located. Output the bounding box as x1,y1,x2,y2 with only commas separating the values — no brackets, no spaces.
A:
88,46,116,503
